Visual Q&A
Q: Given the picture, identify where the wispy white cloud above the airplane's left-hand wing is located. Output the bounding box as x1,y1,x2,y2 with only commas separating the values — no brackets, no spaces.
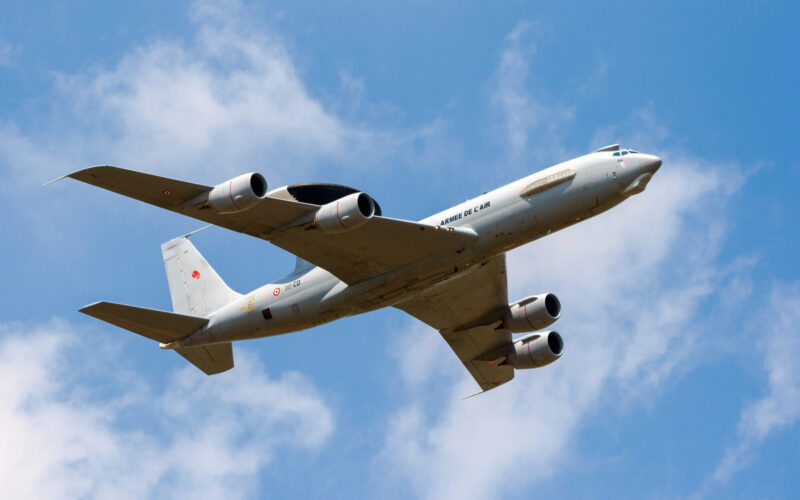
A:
0,1,410,189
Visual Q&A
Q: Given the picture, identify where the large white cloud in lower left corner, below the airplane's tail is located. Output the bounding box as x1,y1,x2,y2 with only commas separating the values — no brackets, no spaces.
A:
0,322,334,498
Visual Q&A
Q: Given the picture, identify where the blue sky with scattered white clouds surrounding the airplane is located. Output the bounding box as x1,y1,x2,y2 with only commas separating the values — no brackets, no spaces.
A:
0,0,800,499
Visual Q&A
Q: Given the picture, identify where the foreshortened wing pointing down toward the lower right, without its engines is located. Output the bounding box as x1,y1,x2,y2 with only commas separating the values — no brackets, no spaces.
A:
395,255,514,391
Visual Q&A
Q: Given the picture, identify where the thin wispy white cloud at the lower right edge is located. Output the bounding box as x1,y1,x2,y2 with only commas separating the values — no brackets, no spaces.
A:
699,286,800,486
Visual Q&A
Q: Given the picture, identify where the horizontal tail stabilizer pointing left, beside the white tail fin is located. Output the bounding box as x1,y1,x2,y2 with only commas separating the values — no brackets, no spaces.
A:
80,302,208,344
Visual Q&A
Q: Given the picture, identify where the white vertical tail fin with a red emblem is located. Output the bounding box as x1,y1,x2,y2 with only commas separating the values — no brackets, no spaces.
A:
161,236,241,316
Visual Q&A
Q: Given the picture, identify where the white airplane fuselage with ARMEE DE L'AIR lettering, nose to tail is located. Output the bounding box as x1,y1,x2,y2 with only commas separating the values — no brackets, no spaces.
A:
181,150,661,348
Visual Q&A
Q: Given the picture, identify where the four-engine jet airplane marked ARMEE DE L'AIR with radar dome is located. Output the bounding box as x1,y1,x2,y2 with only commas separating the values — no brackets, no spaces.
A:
48,144,661,394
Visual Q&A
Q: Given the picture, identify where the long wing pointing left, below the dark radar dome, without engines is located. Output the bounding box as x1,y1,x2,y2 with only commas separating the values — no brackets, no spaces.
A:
67,166,476,284
